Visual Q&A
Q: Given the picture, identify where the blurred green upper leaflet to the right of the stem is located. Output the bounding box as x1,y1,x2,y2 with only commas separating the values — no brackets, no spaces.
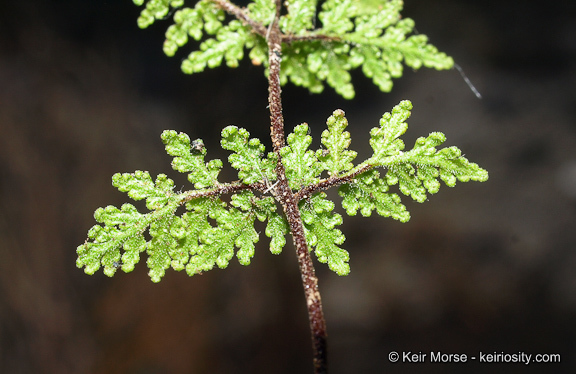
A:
284,0,454,99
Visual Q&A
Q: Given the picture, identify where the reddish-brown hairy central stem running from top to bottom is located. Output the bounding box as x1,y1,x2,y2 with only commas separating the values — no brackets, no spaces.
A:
267,1,327,374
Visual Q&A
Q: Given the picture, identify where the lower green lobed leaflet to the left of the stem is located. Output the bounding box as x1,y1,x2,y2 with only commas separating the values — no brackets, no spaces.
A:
76,127,288,282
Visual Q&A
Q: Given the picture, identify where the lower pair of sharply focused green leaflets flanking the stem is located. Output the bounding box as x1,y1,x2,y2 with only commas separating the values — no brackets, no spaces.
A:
77,101,488,282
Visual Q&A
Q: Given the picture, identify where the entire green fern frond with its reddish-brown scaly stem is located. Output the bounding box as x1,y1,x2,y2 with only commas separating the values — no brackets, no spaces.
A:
76,0,488,373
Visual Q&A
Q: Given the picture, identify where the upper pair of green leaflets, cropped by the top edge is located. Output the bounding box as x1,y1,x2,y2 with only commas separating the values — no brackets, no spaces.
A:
134,0,453,98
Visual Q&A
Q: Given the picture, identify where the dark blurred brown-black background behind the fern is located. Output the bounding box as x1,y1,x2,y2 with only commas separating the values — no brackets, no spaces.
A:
0,0,576,374
